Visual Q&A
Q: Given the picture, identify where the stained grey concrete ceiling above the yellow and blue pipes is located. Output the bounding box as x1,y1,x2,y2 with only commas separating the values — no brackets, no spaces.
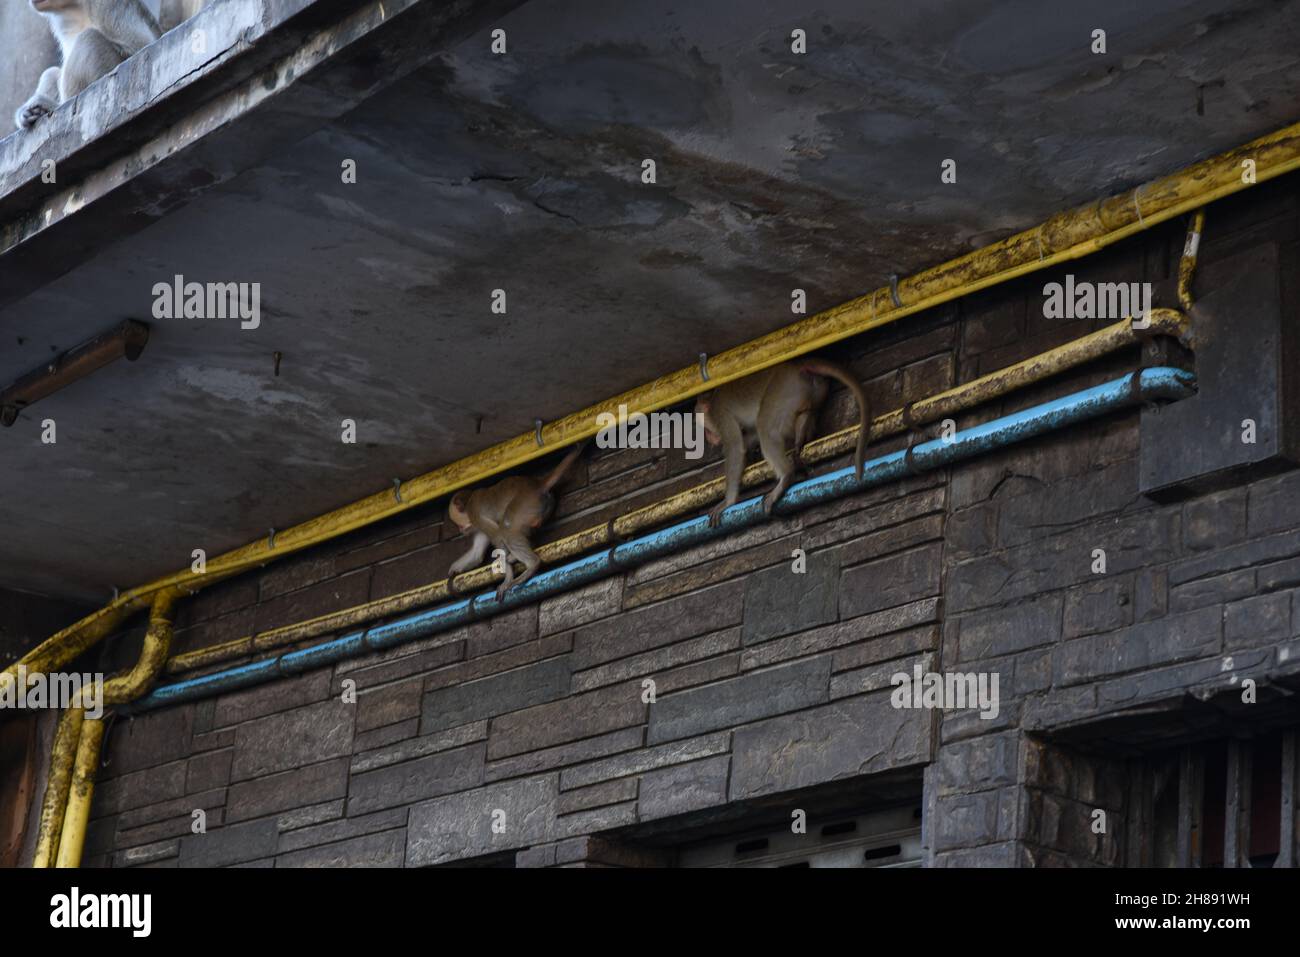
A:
0,0,1300,599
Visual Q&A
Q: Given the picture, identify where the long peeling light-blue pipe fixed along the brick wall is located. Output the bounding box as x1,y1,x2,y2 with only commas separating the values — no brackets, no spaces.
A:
121,367,1196,713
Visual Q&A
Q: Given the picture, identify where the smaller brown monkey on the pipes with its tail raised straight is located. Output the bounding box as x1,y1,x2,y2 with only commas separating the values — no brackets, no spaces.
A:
447,443,582,601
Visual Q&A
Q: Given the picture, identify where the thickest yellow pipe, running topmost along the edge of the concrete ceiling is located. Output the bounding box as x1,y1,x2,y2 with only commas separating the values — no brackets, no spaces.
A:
10,124,1300,686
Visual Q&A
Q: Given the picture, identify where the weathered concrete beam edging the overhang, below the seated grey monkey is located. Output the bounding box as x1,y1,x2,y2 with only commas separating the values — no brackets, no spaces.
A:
0,0,521,306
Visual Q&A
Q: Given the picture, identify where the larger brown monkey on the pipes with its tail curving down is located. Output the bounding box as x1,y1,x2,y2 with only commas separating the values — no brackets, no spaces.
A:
696,358,871,528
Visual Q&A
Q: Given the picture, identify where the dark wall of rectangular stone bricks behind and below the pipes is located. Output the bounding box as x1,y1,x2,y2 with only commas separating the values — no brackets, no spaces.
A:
78,174,1300,866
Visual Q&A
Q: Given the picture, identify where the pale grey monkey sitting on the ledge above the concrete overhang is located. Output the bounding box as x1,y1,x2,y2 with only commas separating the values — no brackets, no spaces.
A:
14,0,163,130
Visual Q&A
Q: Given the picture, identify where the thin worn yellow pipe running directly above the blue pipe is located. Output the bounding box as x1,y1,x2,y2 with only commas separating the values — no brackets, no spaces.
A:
166,308,1188,675
